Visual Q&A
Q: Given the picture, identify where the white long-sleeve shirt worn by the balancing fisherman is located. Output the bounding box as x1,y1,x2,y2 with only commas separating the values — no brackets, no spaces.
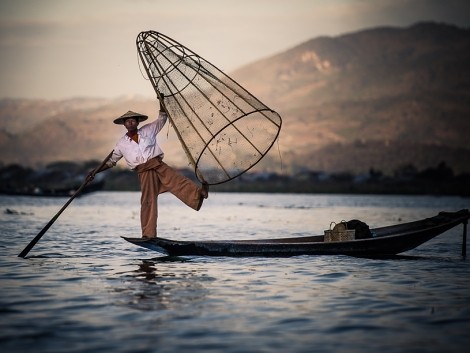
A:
107,111,168,169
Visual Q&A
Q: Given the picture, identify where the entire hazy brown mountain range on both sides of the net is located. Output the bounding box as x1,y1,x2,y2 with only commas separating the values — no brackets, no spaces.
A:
0,23,470,172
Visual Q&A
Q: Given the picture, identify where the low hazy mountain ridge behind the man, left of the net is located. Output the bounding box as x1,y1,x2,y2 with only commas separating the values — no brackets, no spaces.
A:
0,97,191,166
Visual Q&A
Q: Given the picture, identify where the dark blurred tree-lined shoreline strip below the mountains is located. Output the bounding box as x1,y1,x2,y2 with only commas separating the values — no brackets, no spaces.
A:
0,162,470,197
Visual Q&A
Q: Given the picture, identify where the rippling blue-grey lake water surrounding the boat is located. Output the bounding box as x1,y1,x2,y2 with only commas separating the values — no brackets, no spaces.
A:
0,192,470,353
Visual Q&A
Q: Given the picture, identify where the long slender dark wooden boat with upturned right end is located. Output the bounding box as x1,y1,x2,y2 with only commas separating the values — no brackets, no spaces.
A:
124,209,470,257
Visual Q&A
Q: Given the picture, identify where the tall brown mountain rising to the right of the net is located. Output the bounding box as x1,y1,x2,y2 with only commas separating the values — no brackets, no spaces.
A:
233,23,470,171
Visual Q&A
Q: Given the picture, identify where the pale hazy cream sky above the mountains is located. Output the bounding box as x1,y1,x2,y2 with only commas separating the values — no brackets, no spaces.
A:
0,0,470,99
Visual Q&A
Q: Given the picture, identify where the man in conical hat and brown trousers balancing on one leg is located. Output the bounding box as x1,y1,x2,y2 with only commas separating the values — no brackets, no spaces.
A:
87,95,209,238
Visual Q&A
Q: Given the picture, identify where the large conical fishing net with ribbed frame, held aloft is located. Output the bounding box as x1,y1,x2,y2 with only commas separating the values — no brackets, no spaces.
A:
137,31,282,184
